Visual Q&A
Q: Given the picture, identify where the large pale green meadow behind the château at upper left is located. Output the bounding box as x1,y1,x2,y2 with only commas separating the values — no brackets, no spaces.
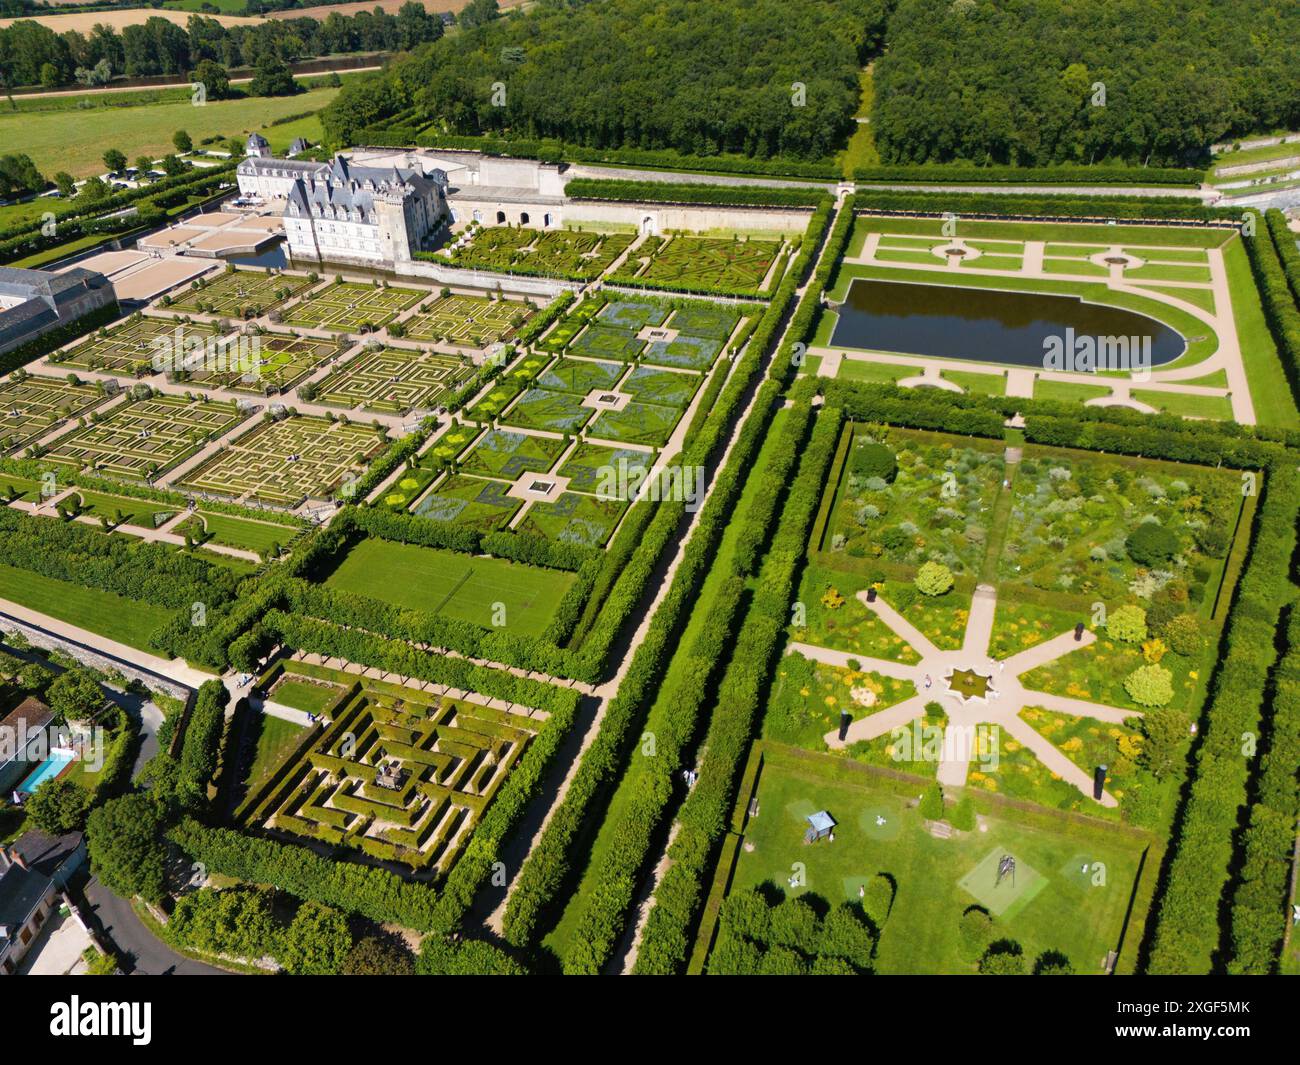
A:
0,88,338,178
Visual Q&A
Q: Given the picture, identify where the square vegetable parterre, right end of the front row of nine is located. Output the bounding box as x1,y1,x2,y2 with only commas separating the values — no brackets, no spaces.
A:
181,417,385,507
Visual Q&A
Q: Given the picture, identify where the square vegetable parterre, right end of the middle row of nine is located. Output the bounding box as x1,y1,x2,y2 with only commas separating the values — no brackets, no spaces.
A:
317,347,475,414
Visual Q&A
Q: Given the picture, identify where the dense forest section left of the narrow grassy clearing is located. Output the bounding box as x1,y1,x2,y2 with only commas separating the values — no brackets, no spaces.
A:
325,0,891,159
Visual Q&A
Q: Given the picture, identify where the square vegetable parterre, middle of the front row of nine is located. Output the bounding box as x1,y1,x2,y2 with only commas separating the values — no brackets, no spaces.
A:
43,395,244,480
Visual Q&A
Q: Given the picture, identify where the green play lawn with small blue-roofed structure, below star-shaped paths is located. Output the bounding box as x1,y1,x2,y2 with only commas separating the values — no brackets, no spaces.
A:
731,745,1154,974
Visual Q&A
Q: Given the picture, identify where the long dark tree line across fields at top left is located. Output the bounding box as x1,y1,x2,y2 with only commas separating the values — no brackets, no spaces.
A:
0,0,443,87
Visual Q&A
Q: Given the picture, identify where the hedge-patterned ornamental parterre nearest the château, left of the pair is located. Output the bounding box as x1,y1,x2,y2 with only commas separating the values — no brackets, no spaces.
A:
451,226,636,281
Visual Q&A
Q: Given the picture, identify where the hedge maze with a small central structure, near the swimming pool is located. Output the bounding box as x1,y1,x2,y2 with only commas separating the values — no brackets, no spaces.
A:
252,689,538,873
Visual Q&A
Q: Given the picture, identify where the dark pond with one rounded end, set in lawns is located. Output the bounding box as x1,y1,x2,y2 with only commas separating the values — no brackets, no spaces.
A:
831,280,1187,372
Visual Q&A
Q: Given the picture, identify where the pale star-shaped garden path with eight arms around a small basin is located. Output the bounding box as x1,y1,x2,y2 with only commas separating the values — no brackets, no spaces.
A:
816,584,1139,806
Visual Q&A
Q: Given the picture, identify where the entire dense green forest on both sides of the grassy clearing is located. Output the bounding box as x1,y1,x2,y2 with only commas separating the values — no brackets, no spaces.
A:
325,0,1300,166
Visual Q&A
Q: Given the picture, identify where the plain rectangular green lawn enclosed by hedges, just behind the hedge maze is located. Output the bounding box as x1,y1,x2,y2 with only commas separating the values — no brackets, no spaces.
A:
325,538,575,636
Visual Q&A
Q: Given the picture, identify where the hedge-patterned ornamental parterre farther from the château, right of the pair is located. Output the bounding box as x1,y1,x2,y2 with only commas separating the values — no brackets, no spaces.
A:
611,237,781,294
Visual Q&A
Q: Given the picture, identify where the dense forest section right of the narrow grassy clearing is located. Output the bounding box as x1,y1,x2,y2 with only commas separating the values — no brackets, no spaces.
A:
872,0,1300,166
